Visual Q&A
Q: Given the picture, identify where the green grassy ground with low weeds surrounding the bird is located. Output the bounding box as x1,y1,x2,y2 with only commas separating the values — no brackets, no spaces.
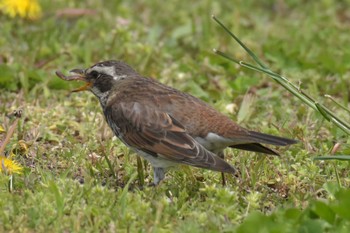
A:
0,0,350,232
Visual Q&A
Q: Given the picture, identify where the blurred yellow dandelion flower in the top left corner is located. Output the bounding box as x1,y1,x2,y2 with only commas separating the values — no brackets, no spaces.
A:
0,0,41,20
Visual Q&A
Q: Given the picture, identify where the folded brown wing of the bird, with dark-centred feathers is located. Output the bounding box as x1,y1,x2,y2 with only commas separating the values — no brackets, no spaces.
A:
105,102,235,173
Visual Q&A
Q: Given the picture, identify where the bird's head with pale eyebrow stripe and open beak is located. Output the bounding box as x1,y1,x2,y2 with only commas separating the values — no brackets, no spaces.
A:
56,60,137,98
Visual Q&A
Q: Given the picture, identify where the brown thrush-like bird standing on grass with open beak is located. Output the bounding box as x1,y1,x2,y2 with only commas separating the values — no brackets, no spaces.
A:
56,60,297,185
